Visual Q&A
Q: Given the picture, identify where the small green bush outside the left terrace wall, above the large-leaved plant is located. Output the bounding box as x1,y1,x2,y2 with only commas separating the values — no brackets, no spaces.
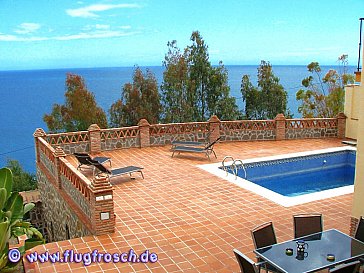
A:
6,159,37,192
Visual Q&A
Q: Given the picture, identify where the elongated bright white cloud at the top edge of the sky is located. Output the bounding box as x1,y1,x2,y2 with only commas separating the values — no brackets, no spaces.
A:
66,4,140,18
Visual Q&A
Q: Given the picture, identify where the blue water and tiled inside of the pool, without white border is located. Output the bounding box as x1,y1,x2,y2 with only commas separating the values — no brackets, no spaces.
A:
222,150,356,197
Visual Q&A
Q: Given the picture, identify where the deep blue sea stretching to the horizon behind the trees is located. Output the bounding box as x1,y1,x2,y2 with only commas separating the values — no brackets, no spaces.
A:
0,65,355,173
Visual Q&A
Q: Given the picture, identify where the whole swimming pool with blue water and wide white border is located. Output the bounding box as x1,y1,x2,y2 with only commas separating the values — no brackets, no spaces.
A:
200,147,356,207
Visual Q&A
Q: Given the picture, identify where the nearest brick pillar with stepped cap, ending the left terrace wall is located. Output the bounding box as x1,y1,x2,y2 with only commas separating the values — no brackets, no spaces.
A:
90,175,115,235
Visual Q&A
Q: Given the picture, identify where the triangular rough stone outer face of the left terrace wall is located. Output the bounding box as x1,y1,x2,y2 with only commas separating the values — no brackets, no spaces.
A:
37,167,91,242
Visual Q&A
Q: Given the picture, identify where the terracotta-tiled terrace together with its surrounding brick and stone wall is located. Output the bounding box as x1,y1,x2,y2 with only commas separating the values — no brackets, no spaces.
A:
25,115,353,272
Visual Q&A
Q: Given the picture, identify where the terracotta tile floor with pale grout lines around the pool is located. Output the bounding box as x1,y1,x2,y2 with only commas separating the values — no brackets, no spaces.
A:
27,139,352,273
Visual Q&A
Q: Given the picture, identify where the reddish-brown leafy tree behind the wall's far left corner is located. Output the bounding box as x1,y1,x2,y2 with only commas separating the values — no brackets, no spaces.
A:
43,73,107,132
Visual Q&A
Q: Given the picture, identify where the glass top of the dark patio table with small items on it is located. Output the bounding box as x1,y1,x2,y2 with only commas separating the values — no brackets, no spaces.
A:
254,229,364,273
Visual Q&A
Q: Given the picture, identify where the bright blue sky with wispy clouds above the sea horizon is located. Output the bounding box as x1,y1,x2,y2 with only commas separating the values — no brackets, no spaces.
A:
0,0,364,70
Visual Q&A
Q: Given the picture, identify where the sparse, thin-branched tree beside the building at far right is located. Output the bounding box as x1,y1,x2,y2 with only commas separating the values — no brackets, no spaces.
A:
296,54,354,118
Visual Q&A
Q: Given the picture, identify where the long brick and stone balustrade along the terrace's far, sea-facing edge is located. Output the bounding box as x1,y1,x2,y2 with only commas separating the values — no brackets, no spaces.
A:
41,115,345,154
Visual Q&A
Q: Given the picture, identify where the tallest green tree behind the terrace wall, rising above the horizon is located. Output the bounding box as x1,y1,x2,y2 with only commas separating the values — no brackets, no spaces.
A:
161,31,240,122
